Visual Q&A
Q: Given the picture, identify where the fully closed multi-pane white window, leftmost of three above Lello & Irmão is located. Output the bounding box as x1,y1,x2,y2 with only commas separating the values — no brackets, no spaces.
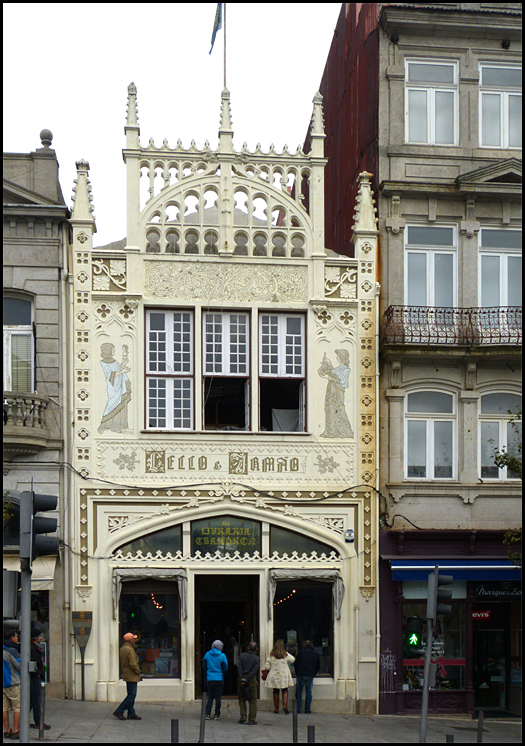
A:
145,308,195,431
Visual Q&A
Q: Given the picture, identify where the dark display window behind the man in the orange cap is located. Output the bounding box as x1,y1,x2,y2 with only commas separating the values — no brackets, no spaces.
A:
120,580,180,679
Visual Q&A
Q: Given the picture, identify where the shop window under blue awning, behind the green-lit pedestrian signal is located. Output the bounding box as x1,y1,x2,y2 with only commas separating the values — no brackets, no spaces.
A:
403,599,466,690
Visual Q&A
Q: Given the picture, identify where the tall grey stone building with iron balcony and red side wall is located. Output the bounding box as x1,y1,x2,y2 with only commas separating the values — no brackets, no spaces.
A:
320,3,522,713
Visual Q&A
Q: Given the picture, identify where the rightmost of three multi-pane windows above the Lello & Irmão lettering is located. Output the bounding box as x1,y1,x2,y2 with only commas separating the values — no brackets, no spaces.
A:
259,314,305,432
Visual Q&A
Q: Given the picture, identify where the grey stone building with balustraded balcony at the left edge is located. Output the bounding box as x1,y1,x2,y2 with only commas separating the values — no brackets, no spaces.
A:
3,130,69,696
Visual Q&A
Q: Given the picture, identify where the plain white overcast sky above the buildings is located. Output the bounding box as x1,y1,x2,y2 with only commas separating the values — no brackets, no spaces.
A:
3,3,341,246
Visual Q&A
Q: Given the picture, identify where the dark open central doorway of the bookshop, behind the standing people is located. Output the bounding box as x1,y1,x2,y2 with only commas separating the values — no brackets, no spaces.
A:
195,575,259,697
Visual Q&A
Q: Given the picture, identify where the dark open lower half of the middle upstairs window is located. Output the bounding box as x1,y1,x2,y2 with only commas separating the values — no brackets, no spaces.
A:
203,377,248,430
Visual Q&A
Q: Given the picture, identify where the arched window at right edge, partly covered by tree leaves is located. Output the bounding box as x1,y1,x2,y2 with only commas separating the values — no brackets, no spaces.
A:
479,393,521,479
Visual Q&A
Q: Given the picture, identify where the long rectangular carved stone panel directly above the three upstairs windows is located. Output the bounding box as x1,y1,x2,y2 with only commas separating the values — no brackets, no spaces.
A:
145,262,308,303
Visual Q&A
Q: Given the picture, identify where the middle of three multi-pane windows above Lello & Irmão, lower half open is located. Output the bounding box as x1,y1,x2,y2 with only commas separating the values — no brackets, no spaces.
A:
202,311,250,430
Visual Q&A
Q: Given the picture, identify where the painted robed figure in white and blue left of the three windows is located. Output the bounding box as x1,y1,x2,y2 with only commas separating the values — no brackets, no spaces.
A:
98,342,131,433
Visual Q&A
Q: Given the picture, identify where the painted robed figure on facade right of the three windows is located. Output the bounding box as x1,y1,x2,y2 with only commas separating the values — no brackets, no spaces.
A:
318,350,354,438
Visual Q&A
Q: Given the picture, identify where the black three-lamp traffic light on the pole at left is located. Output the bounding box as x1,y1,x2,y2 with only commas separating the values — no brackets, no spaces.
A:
20,491,59,570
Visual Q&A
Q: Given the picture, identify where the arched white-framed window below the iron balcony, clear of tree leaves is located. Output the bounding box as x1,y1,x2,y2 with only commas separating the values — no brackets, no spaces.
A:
405,391,456,479
